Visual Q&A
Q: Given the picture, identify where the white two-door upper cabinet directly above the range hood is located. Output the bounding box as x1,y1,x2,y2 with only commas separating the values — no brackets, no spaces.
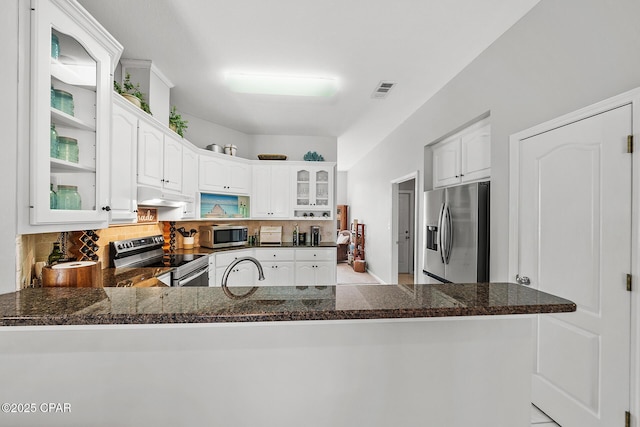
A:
138,120,182,192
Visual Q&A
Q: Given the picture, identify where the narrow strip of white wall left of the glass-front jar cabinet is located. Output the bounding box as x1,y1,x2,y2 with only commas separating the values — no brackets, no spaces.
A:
0,0,19,294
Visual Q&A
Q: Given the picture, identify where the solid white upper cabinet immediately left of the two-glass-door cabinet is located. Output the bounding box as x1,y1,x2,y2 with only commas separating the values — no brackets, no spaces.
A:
251,164,291,219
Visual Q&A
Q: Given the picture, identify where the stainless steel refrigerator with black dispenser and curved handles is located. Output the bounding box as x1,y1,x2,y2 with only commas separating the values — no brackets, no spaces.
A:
423,182,490,283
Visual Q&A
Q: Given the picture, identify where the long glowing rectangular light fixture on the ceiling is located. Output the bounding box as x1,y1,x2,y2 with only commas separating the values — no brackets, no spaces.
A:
226,73,338,97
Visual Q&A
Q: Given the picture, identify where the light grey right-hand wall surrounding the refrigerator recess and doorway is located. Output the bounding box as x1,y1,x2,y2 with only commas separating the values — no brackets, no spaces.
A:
348,0,640,281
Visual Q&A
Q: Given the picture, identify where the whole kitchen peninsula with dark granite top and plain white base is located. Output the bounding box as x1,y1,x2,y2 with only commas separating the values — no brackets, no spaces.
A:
0,283,575,427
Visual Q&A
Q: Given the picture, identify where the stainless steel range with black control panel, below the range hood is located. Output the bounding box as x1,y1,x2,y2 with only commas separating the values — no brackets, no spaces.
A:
109,235,209,286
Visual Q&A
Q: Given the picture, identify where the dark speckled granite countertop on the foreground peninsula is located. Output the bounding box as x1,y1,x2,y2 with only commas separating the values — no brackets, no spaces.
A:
0,283,576,326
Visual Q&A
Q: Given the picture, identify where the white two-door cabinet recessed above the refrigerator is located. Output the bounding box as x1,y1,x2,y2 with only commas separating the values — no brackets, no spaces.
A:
433,122,491,188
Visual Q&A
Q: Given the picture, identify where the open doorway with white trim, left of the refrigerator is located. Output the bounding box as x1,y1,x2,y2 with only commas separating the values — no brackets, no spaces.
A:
391,172,418,286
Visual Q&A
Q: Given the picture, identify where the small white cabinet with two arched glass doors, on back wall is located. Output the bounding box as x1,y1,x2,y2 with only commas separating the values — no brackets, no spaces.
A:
292,163,335,219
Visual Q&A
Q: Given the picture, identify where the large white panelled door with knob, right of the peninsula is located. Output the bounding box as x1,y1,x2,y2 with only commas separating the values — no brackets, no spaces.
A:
512,105,632,427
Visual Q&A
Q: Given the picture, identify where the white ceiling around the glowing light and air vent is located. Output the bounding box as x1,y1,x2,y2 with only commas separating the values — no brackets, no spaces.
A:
79,0,539,170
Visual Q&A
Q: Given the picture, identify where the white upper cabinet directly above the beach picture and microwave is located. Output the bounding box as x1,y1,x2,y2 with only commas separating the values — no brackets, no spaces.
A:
199,153,251,194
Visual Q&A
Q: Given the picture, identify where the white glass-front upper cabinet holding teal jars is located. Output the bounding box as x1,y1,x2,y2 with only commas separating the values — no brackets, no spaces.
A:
29,0,122,228
